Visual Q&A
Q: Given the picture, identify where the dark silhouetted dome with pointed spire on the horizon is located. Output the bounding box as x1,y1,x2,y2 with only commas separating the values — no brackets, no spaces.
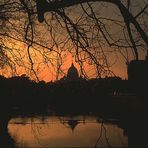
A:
67,63,79,80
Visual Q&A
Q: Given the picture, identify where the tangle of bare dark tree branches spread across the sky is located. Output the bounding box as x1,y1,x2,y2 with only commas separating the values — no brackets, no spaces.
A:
0,0,148,79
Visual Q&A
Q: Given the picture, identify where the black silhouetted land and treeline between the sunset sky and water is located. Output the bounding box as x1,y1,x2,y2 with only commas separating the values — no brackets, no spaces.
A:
0,74,148,148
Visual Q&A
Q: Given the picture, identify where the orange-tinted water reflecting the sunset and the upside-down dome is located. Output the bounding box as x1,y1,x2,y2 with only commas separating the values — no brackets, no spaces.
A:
8,116,128,148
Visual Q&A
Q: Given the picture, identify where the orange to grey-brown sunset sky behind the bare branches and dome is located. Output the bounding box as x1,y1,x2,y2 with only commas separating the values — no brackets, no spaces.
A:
0,0,147,81
